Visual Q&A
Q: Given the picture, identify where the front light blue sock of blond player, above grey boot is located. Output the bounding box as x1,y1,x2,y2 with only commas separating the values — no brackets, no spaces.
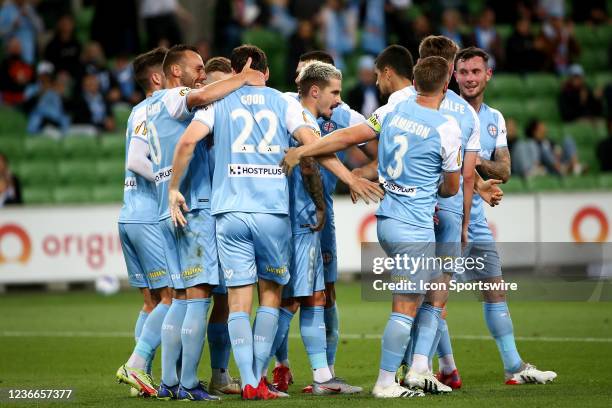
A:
300,306,327,370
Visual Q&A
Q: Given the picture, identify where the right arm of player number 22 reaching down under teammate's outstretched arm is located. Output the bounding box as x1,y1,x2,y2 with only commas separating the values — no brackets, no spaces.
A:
290,125,384,204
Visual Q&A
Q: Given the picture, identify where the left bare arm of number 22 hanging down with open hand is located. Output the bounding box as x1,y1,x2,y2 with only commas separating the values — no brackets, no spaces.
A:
168,120,210,227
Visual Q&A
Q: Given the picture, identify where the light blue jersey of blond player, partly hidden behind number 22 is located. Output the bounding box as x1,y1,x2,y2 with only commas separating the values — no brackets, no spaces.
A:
289,109,321,235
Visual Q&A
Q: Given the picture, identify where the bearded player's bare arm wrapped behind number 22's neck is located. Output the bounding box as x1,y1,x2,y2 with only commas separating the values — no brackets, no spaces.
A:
187,58,266,109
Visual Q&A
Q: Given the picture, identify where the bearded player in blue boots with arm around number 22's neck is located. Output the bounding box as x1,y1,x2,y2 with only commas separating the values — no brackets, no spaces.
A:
147,45,263,400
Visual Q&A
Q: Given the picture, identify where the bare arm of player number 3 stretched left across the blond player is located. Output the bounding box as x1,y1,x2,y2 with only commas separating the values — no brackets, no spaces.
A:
281,123,376,174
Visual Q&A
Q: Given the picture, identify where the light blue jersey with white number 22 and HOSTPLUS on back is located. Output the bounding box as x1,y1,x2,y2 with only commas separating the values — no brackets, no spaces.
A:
194,86,312,215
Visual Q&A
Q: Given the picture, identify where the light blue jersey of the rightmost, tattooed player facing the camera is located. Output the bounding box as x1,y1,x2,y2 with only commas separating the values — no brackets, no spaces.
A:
470,103,508,225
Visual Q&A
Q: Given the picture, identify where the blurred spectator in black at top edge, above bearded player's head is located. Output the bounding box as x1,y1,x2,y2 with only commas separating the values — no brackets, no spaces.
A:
140,0,186,48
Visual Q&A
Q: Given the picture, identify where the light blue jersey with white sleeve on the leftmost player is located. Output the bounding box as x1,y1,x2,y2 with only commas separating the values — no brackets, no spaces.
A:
119,100,158,224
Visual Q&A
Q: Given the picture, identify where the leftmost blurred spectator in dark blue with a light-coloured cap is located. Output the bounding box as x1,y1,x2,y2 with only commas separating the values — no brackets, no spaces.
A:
26,61,70,135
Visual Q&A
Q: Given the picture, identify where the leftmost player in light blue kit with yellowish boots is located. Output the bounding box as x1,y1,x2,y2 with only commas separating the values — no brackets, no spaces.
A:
116,48,172,395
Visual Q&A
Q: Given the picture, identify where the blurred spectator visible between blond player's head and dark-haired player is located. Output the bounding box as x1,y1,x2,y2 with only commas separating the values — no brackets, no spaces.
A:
346,55,382,118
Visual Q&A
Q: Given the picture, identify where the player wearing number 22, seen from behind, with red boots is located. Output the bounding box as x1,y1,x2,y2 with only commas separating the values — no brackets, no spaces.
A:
169,45,378,399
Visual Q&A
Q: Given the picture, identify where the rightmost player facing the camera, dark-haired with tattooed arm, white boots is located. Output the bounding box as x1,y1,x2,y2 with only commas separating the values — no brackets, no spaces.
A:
448,47,557,385
